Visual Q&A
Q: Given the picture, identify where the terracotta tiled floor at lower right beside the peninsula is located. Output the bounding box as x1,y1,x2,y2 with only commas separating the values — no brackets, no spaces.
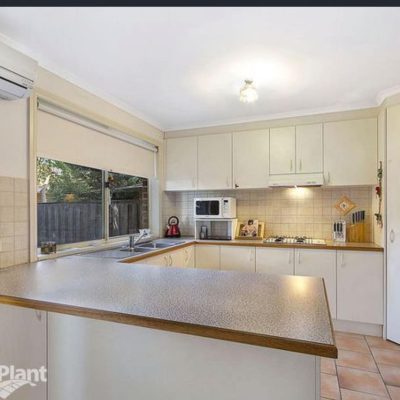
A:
321,332,400,400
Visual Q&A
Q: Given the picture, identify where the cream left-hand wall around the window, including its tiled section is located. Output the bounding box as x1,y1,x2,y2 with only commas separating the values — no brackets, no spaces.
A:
0,68,163,267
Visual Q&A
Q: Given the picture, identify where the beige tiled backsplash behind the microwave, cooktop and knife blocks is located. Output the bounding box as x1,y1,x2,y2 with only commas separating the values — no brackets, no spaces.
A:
163,187,373,241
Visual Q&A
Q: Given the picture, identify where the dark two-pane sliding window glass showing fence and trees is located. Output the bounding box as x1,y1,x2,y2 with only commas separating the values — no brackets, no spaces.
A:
36,157,149,247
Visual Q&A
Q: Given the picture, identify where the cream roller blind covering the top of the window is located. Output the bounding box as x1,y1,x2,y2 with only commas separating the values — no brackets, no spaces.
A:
37,101,157,178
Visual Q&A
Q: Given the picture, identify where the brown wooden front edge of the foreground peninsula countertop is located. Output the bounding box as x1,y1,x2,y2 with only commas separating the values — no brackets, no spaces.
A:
0,296,338,358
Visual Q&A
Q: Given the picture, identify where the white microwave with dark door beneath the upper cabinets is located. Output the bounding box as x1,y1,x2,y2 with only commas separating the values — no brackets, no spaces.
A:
194,197,236,218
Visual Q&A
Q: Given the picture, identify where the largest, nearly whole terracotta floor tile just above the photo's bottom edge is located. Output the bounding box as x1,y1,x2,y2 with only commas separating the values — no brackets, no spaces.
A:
337,367,387,397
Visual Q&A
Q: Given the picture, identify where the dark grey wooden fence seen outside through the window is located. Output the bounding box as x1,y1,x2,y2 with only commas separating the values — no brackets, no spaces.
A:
38,200,140,246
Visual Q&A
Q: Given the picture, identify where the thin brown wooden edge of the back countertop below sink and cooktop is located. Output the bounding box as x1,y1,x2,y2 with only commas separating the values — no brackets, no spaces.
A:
120,239,383,264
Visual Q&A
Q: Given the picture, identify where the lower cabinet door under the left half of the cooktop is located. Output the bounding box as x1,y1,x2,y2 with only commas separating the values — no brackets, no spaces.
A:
256,247,294,275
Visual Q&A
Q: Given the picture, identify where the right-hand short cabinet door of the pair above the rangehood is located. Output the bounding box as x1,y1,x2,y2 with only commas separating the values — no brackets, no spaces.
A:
296,124,323,174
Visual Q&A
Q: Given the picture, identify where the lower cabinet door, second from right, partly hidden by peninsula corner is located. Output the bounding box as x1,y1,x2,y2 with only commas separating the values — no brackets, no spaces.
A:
295,249,336,318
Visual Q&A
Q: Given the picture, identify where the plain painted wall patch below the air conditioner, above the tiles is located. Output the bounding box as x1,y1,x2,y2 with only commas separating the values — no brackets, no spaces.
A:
0,100,28,178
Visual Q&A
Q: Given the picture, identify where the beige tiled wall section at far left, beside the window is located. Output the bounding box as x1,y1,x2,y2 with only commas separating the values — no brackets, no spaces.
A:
0,177,29,268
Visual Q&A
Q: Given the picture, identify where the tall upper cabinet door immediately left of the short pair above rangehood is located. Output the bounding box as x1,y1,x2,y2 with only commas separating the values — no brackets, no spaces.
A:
233,129,269,189
